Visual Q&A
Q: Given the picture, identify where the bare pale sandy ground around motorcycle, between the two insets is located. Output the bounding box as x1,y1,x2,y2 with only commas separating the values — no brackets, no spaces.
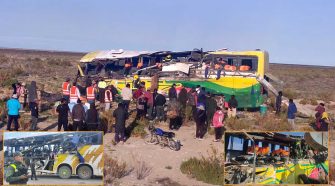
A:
104,122,224,186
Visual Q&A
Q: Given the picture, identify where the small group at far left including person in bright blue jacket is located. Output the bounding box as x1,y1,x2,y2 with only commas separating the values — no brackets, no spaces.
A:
6,81,40,131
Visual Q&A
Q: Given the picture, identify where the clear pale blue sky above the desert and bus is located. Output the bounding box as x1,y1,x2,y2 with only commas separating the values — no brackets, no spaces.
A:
0,0,335,66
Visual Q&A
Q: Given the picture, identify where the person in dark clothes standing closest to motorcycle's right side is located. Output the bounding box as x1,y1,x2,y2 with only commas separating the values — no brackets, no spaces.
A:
194,104,207,140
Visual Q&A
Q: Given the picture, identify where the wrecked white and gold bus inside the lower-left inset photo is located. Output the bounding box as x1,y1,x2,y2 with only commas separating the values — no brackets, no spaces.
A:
4,132,104,179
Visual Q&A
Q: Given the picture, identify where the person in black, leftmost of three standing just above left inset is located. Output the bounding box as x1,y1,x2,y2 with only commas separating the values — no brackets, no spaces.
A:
56,98,70,131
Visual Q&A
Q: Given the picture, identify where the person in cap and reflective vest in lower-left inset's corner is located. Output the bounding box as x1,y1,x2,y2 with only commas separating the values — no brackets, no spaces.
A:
5,152,29,185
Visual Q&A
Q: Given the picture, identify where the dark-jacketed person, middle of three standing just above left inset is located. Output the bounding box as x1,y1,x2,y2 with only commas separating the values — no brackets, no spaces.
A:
72,99,86,131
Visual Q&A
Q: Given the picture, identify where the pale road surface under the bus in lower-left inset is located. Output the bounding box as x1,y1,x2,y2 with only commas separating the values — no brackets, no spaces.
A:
5,175,102,185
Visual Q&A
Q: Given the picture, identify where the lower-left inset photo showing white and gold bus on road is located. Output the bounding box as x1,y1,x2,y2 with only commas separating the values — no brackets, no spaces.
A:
3,132,104,185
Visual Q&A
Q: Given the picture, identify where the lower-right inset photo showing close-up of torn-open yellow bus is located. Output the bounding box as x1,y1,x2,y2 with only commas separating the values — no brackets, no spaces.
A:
224,132,329,184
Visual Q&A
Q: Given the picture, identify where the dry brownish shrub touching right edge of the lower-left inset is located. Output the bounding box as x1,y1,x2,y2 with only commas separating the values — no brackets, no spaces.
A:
104,156,133,185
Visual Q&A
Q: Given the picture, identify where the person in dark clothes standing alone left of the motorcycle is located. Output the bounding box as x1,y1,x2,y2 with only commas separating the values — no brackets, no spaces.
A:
113,103,128,143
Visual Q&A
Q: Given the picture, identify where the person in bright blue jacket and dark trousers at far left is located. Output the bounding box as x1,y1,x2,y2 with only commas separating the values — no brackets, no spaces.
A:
6,94,21,131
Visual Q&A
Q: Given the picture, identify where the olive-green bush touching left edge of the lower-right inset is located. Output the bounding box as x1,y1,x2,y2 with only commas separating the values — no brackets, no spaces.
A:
180,149,224,185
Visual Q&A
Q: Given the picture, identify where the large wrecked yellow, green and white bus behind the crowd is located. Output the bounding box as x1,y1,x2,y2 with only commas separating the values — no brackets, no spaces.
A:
78,50,277,108
